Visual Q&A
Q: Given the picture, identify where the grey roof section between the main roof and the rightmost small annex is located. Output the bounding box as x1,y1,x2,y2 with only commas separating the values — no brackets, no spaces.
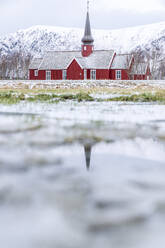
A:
111,54,133,70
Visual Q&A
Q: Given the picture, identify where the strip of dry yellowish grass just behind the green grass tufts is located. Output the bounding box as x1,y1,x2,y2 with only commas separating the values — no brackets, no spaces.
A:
0,82,165,96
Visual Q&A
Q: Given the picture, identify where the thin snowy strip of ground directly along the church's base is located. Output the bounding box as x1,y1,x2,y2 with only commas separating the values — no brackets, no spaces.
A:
0,80,165,89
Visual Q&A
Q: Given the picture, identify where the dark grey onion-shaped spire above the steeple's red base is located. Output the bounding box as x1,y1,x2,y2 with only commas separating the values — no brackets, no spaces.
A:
81,11,94,45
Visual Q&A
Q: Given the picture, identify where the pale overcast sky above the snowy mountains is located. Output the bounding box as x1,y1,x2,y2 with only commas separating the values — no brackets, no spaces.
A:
0,0,165,34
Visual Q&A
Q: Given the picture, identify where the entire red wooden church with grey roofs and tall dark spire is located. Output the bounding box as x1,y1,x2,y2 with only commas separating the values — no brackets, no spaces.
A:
29,6,150,80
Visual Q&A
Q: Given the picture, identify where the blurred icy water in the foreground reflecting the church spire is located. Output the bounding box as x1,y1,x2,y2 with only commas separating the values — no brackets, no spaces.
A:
0,101,165,248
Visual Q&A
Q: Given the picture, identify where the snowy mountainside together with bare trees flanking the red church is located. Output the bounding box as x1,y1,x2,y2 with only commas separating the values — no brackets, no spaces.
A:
0,22,165,79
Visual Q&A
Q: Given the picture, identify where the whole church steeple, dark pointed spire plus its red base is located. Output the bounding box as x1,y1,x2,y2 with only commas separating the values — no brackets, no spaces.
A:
81,0,94,57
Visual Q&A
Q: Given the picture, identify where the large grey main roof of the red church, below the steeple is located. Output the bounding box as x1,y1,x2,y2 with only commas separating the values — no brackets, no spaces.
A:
36,50,114,70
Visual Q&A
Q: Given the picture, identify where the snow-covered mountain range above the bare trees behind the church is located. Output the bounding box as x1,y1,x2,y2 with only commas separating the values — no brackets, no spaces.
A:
0,22,165,56
